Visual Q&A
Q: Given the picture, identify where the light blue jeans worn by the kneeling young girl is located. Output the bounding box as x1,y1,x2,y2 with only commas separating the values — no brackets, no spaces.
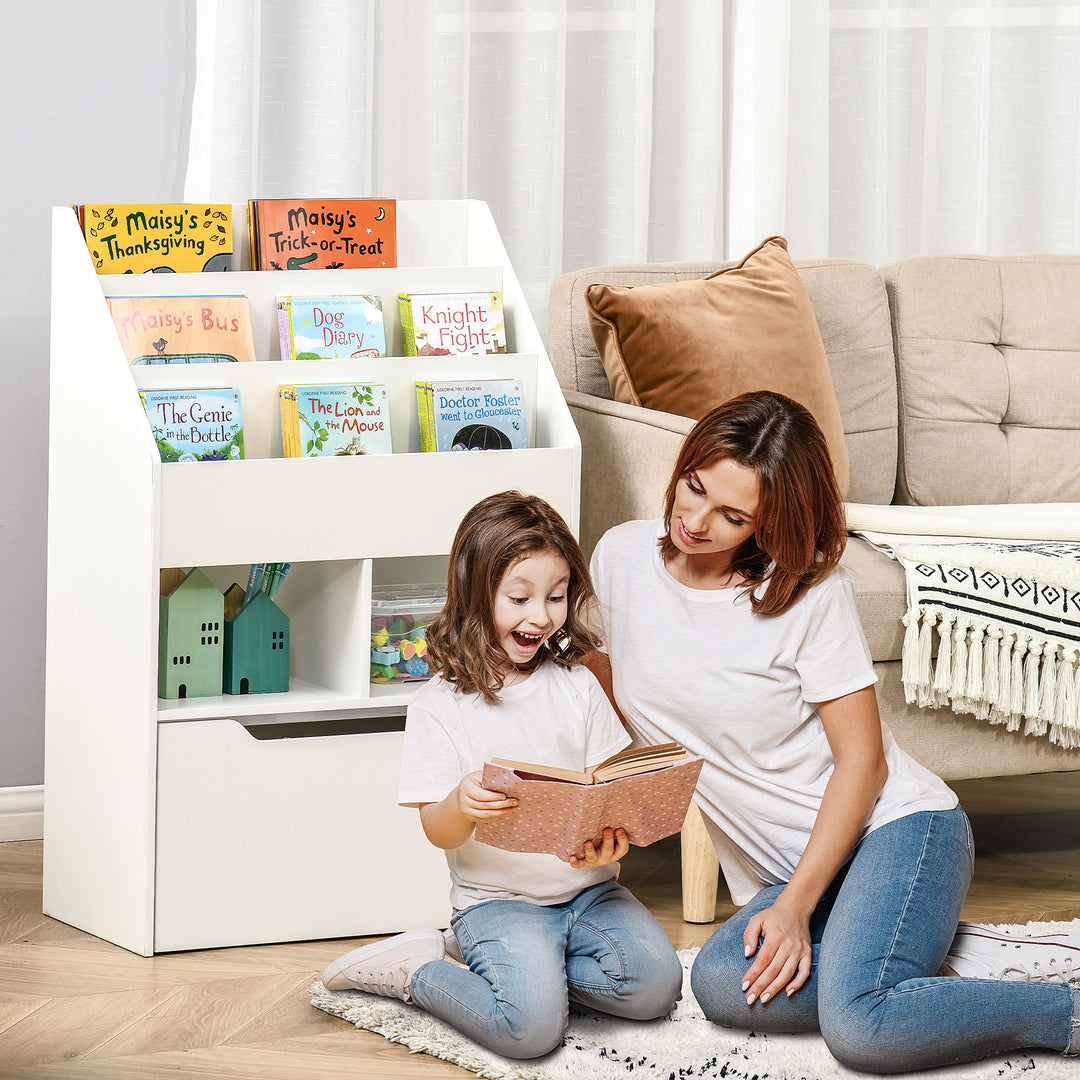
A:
409,881,683,1057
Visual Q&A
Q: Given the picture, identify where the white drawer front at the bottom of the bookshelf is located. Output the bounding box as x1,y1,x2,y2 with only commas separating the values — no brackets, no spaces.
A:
153,719,449,953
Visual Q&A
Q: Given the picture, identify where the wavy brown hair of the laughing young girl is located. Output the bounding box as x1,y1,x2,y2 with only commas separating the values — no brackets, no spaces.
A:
428,491,599,703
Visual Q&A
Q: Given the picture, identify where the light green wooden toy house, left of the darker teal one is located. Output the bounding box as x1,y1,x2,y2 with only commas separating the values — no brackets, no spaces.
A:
158,567,225,698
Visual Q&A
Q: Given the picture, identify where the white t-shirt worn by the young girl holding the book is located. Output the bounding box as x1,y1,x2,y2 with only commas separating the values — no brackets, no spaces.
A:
397,663,631,909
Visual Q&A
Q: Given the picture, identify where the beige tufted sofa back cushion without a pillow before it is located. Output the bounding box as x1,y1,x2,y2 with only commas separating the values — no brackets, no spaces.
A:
881,255,1080,505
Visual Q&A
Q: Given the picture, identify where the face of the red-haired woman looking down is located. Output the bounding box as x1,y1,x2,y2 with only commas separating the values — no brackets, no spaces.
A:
671,458,760,555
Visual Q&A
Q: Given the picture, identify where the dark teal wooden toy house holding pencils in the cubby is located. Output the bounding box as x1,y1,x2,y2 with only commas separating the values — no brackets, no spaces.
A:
221,584,288,693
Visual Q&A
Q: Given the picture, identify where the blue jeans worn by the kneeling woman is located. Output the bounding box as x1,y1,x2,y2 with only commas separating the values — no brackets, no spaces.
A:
691,807,1080,1072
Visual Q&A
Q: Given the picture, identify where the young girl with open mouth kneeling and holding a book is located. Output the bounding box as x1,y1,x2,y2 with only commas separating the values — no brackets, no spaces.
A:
323,491,681,1057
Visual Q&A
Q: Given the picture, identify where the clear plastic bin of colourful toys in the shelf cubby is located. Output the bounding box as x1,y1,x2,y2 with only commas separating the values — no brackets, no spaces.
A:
372,584,446,683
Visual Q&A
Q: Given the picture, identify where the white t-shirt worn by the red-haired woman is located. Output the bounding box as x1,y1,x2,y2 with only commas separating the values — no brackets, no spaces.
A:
592,521,957,904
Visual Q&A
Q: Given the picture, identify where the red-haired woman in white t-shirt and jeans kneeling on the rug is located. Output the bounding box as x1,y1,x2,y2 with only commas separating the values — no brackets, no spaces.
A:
592,391,1080,1072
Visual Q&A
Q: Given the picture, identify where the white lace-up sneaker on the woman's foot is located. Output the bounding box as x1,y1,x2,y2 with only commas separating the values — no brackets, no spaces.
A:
945,922,1080,983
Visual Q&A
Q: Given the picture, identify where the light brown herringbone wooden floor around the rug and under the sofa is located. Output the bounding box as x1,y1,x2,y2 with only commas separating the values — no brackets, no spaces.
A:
6,774,1080,1080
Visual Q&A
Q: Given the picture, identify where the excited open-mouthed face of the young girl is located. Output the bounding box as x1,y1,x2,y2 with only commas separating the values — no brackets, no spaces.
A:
495,551,570,674
